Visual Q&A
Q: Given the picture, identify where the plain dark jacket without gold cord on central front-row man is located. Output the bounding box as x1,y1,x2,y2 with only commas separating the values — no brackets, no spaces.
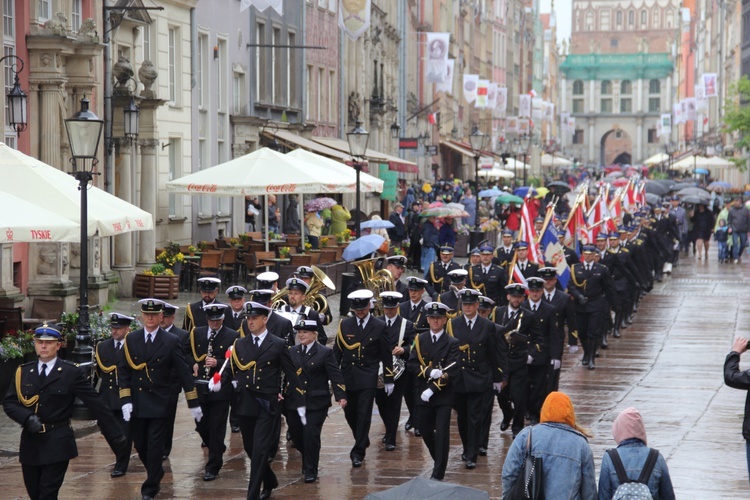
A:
284,342,346,411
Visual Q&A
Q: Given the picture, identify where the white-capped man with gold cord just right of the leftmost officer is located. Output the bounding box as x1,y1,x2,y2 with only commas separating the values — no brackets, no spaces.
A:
94,313,135,477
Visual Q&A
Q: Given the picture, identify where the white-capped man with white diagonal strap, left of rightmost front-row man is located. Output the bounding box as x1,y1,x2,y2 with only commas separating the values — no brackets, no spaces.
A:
375,291,414,451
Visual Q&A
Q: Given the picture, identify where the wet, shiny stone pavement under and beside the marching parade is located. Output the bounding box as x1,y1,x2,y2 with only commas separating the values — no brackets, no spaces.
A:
0,249,750,499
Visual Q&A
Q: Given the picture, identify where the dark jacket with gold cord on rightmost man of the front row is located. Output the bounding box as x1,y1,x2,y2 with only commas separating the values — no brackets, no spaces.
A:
406,331,460,406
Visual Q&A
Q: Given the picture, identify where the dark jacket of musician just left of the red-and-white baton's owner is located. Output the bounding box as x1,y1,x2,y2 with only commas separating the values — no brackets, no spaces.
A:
187,325,240,403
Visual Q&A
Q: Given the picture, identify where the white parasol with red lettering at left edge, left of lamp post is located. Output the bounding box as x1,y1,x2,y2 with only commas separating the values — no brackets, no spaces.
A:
0,193,81,243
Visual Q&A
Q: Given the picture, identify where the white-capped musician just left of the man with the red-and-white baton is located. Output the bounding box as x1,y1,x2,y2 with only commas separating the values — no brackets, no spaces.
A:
188,304,240,481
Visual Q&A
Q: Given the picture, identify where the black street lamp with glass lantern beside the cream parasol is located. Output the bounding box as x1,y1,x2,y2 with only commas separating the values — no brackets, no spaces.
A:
65,96,104,363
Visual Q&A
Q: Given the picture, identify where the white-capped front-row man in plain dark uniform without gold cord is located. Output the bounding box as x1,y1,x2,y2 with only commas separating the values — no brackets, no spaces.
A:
284,319,346,483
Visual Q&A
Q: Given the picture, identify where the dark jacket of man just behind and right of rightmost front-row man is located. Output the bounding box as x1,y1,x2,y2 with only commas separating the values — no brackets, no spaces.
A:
446,314,507,393
